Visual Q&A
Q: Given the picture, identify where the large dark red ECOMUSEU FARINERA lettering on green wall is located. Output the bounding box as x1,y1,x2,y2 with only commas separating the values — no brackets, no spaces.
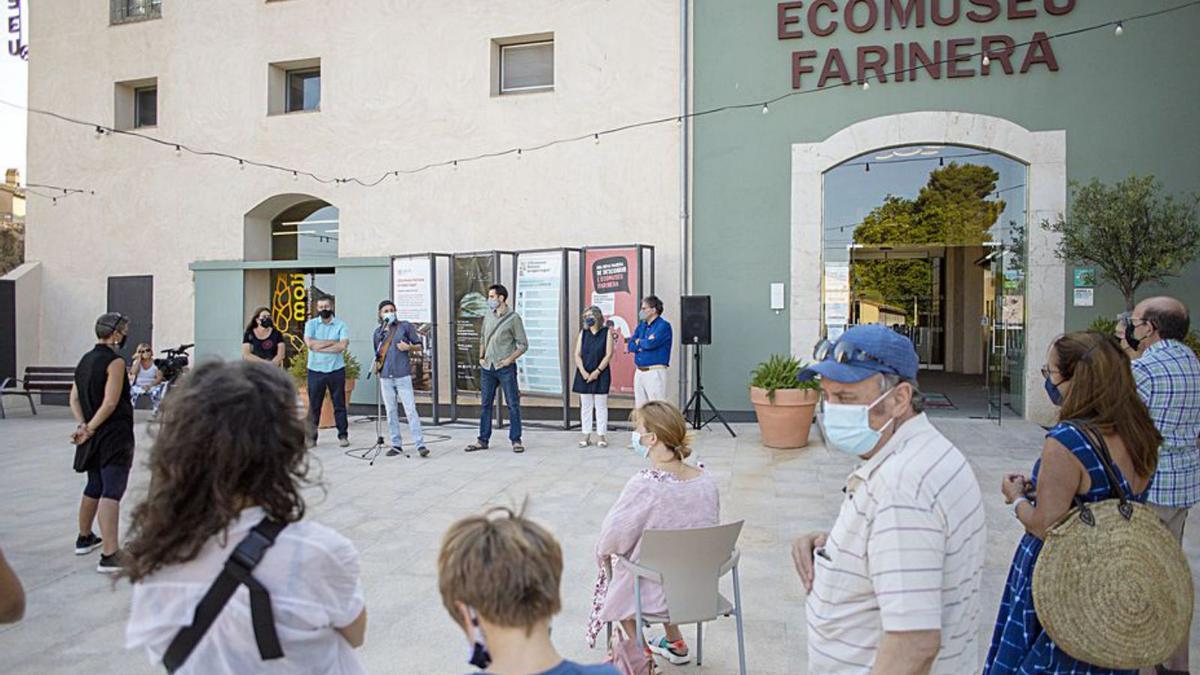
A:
775,0,1075,89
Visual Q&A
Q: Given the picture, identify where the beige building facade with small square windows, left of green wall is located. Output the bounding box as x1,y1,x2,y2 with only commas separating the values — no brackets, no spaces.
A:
20,0,682,403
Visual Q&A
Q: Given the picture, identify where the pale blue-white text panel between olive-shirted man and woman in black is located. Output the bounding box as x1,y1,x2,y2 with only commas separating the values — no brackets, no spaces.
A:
514,251,563,395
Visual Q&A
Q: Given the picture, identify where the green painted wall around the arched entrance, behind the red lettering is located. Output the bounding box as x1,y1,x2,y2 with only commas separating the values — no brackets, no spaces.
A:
692,0,1200,410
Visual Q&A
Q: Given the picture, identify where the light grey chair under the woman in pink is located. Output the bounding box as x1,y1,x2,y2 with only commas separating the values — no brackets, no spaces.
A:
607,520,746,675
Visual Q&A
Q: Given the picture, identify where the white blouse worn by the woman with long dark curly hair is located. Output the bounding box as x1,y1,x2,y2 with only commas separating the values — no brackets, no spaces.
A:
125,507,365,675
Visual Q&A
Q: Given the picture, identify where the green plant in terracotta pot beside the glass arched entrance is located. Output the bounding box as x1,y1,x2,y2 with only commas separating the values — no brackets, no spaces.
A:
750,354,821,449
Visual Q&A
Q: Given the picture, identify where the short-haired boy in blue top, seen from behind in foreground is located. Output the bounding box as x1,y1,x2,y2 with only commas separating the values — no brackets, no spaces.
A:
438,507,618,675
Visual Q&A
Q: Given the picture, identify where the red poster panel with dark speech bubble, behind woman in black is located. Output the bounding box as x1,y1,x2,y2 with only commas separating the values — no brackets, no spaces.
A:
583,246,642,395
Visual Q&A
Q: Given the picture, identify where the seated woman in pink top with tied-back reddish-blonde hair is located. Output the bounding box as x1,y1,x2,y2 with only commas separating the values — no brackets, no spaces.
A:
588,401,720,664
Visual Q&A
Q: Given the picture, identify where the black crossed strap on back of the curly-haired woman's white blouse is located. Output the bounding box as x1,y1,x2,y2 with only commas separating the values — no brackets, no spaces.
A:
162,518,287,673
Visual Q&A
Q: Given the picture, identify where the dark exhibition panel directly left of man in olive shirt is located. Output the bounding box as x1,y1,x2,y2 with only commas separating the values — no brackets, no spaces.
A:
454,253,496,392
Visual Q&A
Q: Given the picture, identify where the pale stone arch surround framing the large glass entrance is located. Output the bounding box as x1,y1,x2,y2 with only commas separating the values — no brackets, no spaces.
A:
790,112,1067,420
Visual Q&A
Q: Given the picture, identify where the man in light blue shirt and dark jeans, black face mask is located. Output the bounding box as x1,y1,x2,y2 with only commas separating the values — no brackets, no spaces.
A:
304,298,350,448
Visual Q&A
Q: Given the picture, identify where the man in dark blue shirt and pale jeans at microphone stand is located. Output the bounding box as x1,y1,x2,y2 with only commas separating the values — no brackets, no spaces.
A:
373,300,430,458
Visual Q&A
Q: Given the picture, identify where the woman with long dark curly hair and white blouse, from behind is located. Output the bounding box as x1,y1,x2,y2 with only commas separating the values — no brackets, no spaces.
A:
125,362,367,675
